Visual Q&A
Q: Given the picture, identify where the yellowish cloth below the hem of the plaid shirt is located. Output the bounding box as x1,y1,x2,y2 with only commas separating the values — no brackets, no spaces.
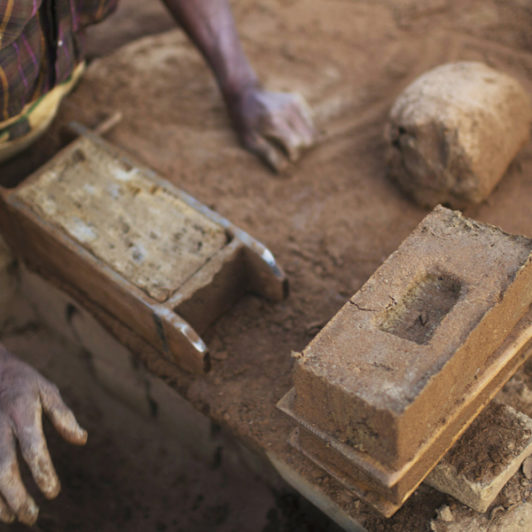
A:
0,62,85,163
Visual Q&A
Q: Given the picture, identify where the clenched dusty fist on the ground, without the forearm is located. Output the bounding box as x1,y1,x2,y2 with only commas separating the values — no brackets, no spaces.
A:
228,86,316,172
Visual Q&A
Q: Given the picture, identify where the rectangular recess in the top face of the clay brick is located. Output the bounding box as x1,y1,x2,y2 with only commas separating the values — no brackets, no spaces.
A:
379,273,461,344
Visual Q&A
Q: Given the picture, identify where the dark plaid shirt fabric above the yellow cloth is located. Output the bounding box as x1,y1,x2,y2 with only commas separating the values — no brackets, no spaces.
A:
0,0,118,122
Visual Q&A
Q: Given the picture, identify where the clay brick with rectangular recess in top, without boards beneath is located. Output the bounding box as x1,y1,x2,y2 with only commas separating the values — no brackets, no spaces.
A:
294,207,532,467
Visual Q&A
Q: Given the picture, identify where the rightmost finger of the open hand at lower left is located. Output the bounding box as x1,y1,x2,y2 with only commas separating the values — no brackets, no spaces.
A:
39,379,87,445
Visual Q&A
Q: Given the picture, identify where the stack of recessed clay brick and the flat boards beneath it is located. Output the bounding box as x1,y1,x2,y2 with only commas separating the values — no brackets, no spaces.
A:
279,207,532,515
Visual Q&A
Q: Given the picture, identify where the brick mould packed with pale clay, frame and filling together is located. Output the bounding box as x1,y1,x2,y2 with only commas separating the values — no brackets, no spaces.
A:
0,126,287,372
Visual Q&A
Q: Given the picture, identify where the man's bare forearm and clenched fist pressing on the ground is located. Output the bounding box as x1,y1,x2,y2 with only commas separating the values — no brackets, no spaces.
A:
163,0,315,171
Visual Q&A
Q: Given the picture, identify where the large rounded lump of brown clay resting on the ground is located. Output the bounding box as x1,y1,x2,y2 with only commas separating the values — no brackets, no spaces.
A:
387,62,532,208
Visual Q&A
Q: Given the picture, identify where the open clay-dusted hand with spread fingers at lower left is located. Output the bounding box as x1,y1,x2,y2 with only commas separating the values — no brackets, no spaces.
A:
0,345,87,525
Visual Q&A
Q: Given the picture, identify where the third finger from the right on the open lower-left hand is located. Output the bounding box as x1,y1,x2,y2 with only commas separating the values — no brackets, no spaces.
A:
0,418,39,525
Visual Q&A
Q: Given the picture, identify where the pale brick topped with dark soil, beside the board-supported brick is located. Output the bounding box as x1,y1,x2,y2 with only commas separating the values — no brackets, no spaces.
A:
425,402,532,513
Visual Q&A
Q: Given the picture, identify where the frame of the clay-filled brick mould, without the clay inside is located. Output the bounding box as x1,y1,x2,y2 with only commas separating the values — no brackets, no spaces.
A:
0,123,288,373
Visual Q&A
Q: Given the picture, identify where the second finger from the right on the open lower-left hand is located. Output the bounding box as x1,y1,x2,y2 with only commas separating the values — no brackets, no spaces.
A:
12,403,61,499
